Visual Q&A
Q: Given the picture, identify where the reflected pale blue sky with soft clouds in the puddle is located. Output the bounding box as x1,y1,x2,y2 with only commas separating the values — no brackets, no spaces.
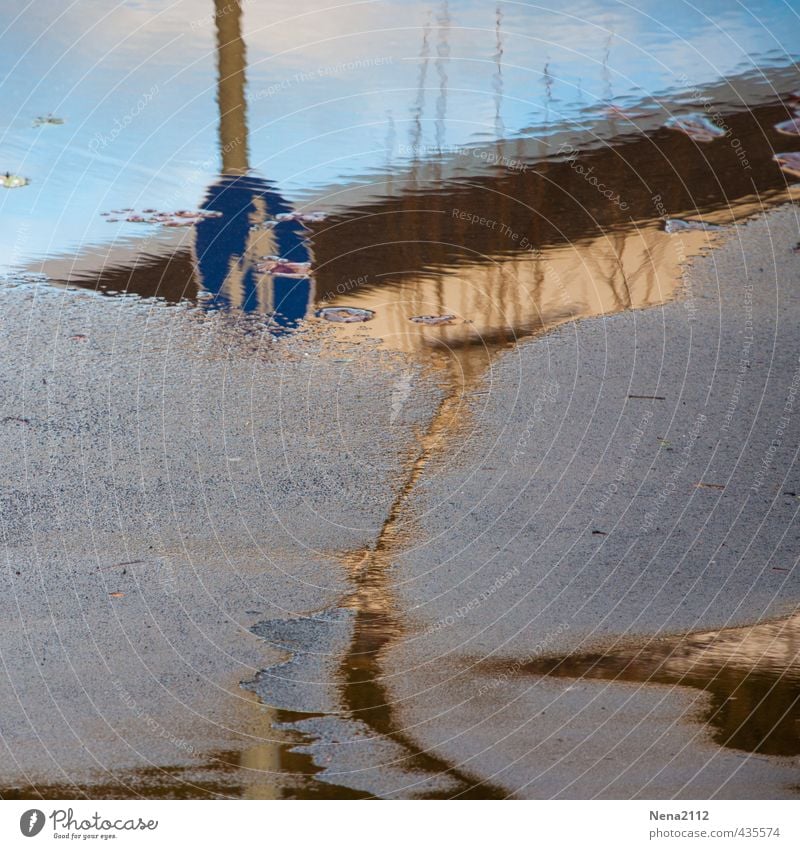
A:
0,0,800,265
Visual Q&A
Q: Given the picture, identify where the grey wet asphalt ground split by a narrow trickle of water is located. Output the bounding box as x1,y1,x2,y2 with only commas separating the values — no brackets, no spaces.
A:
0,206,800,798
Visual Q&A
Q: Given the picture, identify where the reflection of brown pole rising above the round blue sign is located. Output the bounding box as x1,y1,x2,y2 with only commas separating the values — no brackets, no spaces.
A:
214,0,248,174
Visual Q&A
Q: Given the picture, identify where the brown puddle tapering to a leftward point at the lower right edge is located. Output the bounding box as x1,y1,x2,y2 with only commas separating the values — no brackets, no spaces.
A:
496,616,800,756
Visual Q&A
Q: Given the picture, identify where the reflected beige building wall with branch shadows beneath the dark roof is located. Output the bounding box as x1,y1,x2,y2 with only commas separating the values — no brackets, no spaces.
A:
312,225,709,372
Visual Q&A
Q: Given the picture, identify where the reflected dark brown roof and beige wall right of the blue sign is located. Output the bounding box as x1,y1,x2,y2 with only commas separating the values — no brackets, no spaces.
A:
304,93,787,362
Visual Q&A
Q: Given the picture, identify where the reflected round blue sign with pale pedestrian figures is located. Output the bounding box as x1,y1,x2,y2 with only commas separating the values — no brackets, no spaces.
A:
195,174,313,328
